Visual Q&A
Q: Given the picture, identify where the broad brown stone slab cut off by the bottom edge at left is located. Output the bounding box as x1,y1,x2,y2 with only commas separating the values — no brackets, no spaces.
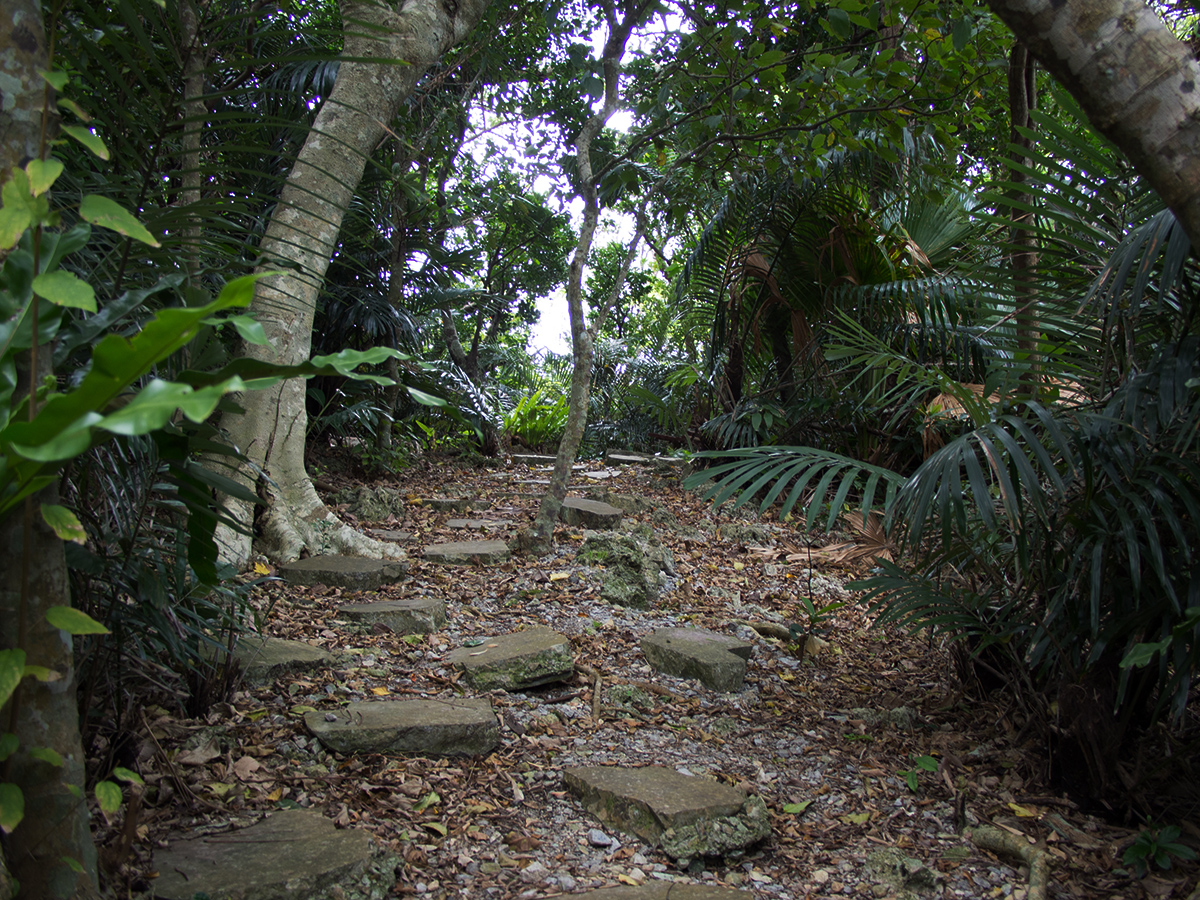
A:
150,810,398,900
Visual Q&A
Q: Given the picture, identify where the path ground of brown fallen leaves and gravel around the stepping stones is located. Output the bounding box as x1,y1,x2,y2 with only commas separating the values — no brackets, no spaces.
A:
100,461,1198,900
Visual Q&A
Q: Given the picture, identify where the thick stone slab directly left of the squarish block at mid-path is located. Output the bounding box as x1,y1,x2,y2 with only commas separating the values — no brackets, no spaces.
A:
445,628,575,691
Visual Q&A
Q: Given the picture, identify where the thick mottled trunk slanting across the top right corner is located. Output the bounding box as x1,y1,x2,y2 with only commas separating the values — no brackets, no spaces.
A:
989,0,1200,247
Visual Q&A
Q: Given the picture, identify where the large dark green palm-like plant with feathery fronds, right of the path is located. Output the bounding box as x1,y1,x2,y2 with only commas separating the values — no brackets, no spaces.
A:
692,103,1200,803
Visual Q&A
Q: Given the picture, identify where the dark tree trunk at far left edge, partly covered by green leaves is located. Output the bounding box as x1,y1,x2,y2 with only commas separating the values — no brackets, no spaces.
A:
0,0,97,898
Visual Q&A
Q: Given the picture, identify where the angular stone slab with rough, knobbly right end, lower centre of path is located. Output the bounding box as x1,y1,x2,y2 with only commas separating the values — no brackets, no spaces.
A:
563,766,770,860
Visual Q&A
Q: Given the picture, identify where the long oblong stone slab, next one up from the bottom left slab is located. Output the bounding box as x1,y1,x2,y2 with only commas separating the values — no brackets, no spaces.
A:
304,697,500,756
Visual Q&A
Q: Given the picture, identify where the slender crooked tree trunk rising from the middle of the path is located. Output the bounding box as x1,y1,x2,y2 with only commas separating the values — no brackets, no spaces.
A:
521,2,652,553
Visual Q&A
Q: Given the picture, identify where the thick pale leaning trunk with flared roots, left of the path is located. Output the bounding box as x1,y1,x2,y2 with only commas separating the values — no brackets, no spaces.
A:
220,0,488,565
